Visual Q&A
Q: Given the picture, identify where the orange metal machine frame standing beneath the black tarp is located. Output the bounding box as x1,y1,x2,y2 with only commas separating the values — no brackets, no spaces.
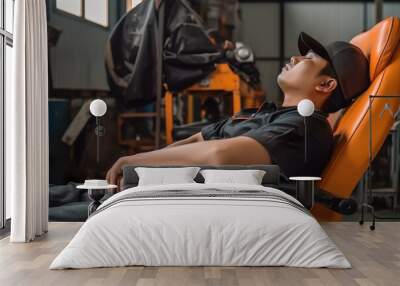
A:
165,64,265,145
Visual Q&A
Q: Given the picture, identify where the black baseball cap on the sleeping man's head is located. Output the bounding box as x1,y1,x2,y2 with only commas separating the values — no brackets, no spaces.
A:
298,32,370,112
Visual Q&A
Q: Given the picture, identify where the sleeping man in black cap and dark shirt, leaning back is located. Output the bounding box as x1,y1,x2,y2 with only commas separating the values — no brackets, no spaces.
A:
107,32,369,187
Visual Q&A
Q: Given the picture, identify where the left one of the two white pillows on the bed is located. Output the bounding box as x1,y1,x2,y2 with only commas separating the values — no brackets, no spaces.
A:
135,167,200,186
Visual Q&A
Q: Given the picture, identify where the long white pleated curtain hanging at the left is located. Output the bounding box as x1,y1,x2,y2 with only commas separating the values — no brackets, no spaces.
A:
5,0,49,242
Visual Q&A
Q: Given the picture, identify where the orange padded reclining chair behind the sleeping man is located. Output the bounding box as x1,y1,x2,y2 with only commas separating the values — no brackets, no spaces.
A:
312,17,400,221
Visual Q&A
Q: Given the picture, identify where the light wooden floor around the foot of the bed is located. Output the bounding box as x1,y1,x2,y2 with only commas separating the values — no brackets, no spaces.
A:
0,222,400,286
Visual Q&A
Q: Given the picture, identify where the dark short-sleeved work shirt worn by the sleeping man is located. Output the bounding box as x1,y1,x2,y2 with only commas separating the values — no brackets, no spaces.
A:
201,100,333,177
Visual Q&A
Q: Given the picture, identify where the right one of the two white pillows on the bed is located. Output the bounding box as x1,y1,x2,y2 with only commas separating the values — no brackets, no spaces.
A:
200,169,265,185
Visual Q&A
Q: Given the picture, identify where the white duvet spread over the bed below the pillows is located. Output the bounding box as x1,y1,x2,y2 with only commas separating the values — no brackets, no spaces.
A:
50,184,351,269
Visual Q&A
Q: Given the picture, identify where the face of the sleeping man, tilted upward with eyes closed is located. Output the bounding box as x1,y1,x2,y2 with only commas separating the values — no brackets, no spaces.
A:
278,50,328,96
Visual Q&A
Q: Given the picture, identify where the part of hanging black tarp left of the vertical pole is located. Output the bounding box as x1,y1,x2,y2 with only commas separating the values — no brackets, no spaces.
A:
106,0,157,105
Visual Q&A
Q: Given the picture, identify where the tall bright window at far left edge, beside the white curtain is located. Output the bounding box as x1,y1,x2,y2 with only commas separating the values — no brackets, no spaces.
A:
0,0,14,228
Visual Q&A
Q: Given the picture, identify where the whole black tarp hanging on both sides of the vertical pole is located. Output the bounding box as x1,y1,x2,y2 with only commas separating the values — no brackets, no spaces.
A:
106,0,223,107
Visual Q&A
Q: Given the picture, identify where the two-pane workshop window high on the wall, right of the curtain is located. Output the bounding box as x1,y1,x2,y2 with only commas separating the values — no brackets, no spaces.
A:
56,0,108,27
